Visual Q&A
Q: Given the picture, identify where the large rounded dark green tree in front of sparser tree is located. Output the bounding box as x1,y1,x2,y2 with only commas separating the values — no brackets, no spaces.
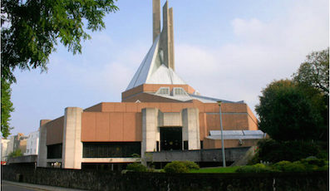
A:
256,80,324,141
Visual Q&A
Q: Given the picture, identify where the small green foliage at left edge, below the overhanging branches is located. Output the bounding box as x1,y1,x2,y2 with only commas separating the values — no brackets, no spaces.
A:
1,80,14,139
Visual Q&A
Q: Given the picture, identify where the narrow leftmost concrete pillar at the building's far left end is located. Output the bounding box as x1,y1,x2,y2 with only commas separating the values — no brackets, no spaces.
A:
37,119,51,167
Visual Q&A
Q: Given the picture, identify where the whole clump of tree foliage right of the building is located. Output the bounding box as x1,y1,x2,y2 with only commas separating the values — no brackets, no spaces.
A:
256,48,329,141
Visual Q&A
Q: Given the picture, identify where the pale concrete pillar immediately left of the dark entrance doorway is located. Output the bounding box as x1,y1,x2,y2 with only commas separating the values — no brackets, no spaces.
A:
141,108,159,158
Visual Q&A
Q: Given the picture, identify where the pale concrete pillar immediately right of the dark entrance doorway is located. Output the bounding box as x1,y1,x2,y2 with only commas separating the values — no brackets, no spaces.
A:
182,108,200,150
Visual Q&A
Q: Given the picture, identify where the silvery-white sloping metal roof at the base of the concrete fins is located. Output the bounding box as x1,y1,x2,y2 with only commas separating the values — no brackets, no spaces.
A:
126,36,186,90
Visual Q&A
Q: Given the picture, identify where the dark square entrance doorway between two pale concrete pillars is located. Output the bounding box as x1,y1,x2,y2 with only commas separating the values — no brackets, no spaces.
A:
160,127,182,151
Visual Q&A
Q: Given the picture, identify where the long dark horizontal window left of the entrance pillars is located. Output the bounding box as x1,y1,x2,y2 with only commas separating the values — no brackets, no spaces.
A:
83,142,141,158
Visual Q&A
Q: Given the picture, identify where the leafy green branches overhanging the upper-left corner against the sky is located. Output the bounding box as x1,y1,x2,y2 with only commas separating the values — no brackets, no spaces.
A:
1,0,118,82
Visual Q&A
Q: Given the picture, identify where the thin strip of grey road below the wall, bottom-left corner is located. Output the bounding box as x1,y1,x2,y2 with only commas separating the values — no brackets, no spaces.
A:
1,180,86,191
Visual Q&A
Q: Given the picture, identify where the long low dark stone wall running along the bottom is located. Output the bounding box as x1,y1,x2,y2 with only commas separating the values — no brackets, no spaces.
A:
2,165,329,191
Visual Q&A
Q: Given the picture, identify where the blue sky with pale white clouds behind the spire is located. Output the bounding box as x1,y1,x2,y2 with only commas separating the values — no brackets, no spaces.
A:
10,0,329,135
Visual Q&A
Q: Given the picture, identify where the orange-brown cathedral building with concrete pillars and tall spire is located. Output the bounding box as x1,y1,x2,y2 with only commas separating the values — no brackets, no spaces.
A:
38,0,264,169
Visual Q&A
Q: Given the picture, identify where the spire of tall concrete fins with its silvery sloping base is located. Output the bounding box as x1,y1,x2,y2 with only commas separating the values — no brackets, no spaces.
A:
126,0,180,90
